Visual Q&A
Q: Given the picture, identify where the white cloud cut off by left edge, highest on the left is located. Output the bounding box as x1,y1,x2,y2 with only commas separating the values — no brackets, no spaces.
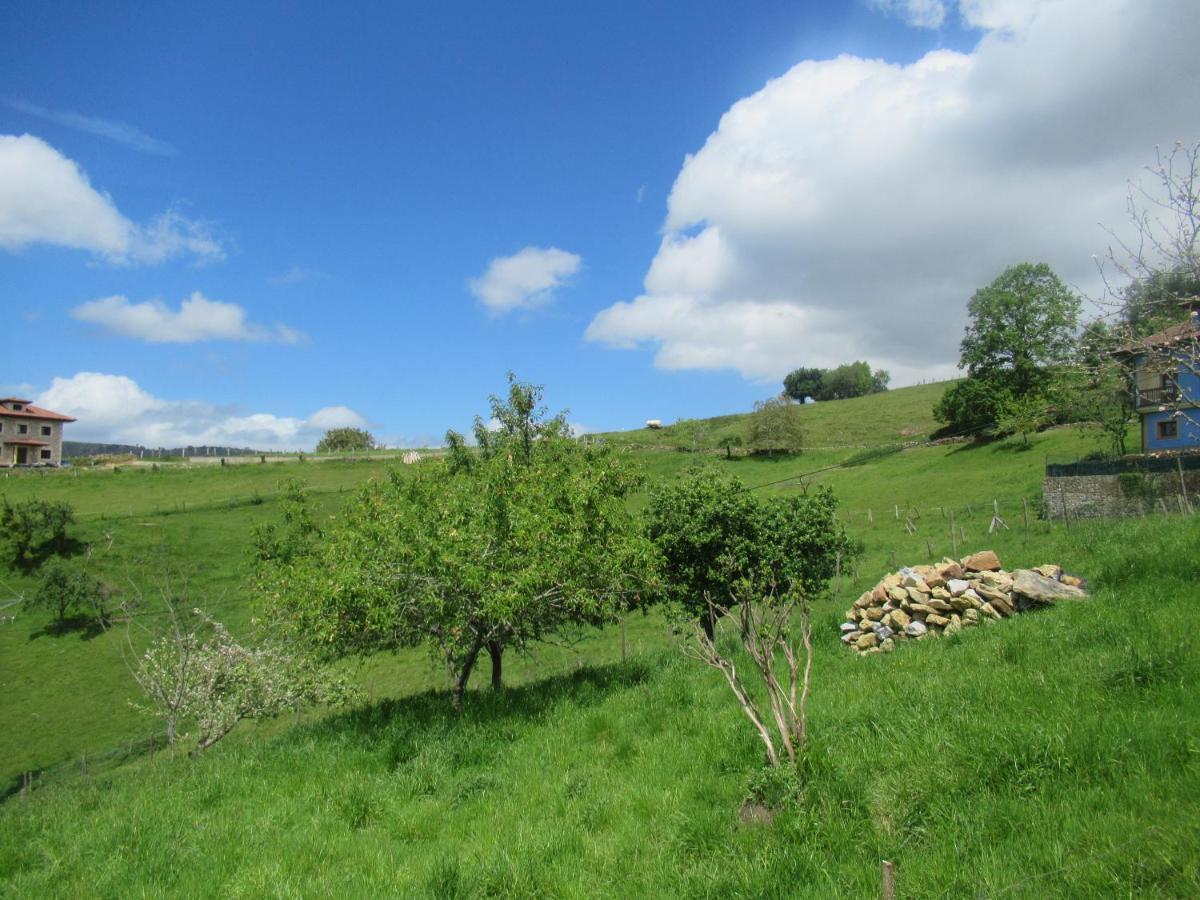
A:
0,134,223,264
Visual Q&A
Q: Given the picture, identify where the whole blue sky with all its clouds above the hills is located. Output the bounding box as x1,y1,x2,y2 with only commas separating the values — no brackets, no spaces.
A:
0,0,1198,446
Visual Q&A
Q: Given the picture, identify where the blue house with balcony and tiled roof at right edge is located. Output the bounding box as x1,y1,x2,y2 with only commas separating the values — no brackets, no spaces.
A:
1126,312,1200,452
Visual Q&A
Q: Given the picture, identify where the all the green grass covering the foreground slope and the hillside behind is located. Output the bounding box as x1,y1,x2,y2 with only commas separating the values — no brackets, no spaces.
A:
0,385,1200,898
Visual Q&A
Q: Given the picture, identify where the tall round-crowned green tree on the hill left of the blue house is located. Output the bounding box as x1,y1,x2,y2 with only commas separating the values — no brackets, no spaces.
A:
959,263,1081,397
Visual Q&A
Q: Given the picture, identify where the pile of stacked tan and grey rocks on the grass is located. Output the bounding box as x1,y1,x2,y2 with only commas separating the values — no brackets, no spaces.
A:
841,550,1087,654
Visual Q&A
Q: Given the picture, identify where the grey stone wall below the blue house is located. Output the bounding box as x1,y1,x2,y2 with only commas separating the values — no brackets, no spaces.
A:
1042,470,1200,520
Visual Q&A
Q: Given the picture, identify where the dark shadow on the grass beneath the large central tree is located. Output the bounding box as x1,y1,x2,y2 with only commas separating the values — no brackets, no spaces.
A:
312,659,656,743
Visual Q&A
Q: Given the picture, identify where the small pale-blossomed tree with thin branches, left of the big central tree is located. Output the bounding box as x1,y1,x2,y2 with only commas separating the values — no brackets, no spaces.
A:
131,610,356,752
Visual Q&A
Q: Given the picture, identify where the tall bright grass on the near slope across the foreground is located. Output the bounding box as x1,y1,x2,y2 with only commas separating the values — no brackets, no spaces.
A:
0,518,1200,898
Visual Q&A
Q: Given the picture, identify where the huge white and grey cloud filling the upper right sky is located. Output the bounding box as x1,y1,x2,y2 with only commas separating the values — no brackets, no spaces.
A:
587,0,1200,384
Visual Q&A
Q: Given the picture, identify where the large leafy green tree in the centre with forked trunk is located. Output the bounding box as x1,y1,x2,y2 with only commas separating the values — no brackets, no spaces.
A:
259,377,654,695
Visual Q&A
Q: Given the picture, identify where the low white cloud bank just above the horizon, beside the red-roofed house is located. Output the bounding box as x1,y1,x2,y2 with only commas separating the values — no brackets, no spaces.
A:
35,372,366,450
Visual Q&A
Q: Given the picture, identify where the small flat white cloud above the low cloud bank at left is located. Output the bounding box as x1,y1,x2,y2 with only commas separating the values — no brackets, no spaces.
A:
71,290,305,343
